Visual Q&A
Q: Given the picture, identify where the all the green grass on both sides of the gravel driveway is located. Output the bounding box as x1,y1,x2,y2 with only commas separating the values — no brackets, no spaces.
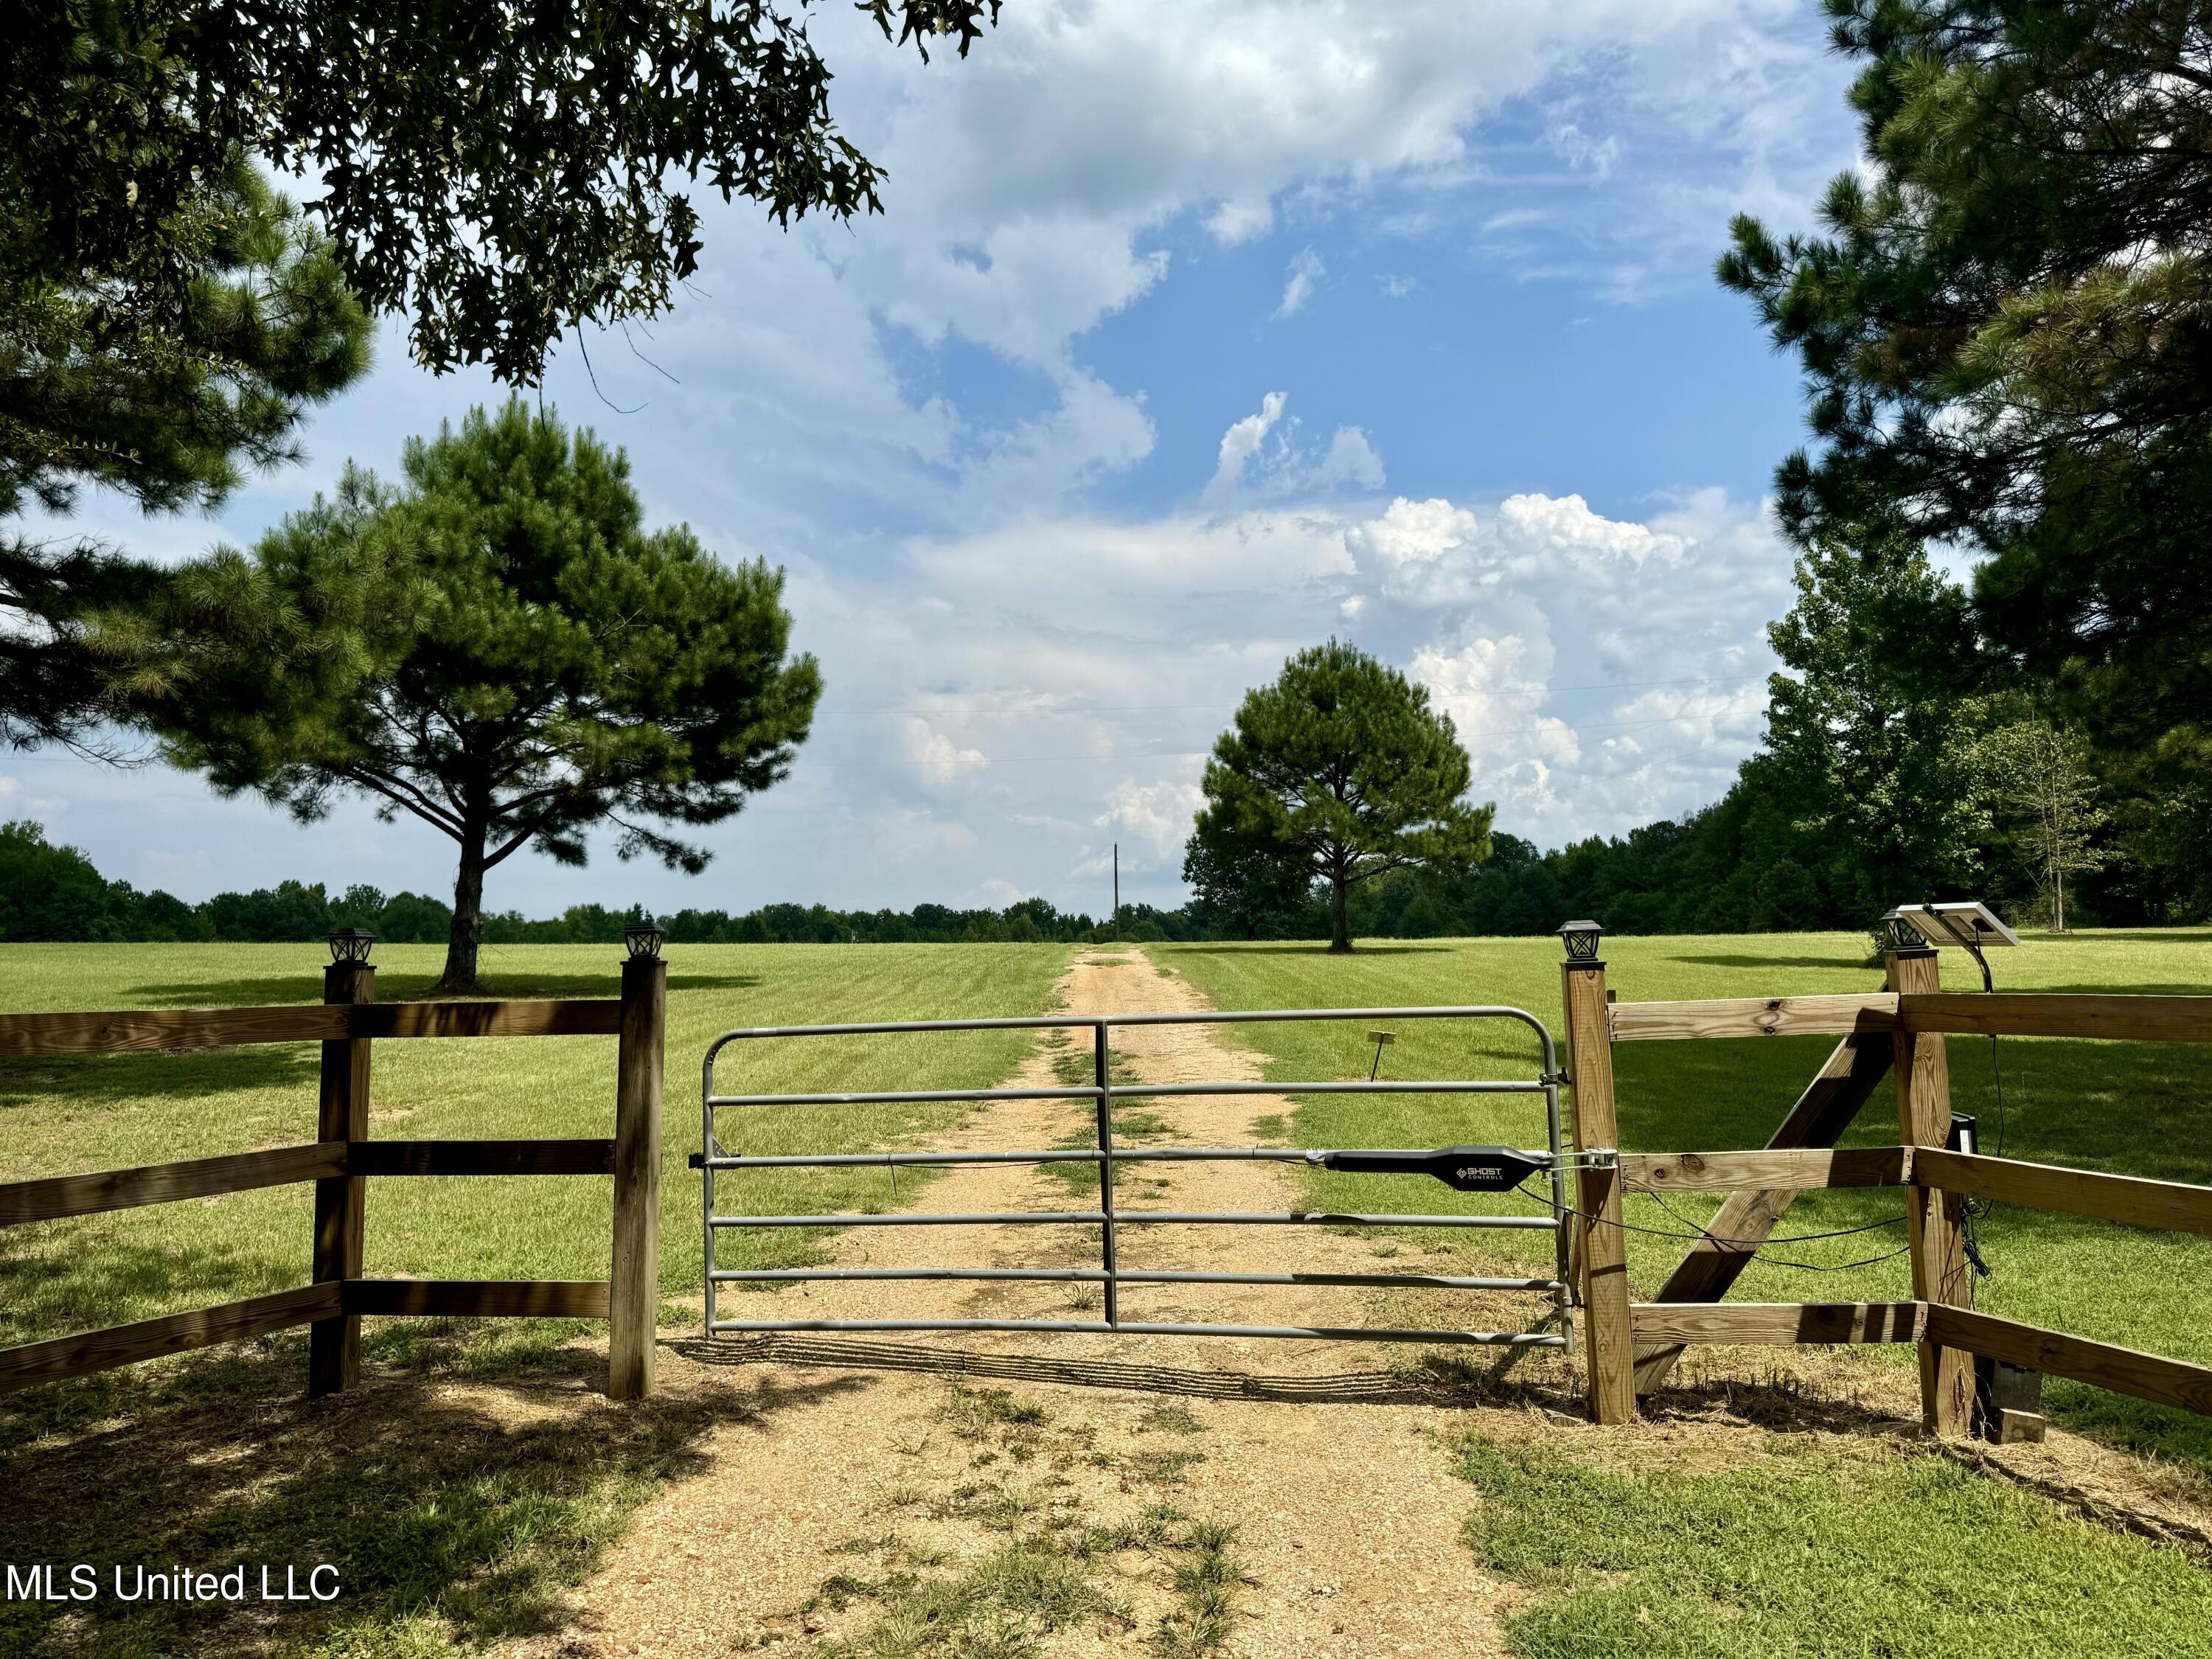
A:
0,931,2212,1659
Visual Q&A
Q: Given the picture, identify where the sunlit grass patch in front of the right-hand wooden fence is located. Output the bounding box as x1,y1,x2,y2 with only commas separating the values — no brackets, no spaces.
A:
1460,1438,2212,1659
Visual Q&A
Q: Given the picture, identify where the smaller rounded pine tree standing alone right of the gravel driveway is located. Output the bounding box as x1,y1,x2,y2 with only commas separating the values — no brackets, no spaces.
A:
1192,639,1495,951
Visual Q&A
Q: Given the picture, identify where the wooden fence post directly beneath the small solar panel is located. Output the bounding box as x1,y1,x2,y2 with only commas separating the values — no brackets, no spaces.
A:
1887,936,1973,1438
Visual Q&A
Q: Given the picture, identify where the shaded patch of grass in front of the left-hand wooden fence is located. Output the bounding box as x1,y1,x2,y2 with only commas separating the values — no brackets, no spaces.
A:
0,1332,867,1659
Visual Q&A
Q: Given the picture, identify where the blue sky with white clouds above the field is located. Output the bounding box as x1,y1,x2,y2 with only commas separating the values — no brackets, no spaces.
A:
0,0,1856,914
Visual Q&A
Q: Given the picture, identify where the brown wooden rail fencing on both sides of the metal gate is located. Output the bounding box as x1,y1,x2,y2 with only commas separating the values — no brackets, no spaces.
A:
0,951,2212,1436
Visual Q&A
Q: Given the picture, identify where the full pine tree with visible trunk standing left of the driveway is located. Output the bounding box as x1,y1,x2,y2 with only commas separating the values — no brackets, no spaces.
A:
148,400,821,993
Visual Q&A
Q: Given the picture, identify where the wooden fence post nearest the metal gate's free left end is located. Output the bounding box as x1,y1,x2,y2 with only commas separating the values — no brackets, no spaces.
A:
606,956,668,1400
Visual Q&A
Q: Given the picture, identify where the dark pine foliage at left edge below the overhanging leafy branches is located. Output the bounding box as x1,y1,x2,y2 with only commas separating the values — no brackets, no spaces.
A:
0,155,369,745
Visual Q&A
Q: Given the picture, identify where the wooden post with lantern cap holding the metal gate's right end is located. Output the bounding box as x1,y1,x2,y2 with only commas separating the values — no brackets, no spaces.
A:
1559,922,1637,1422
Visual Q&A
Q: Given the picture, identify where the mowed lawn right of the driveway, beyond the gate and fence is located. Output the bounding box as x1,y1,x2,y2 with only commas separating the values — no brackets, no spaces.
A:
1148,929,2212,1462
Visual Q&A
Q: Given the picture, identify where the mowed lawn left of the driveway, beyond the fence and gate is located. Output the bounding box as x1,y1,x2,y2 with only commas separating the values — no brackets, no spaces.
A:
0,945,1068,1345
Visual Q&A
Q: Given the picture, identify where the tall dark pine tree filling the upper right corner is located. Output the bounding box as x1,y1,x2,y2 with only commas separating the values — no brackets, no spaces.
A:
1719,0,2212,887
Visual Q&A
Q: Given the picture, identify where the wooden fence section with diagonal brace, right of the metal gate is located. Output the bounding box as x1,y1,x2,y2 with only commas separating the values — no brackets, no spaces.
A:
1562,949,2212,1436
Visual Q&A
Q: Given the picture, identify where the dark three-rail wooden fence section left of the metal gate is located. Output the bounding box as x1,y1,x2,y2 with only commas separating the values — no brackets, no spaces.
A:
0,956,668,1400
